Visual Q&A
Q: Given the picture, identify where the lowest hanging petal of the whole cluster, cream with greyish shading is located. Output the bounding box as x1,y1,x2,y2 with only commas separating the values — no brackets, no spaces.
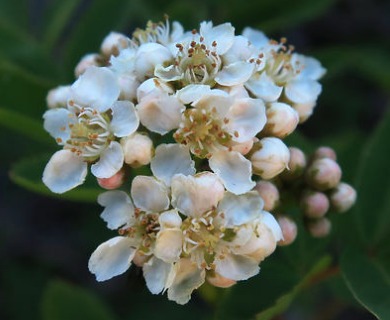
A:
168,259,205,304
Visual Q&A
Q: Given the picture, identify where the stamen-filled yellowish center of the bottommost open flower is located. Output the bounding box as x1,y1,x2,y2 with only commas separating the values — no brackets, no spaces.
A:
182,210,225,269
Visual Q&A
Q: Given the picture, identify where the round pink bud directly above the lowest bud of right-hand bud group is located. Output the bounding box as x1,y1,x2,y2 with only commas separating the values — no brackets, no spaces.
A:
301,191,329,218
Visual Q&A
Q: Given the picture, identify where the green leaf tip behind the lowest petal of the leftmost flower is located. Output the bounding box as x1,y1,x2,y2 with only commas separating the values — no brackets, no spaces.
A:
9,155,102,202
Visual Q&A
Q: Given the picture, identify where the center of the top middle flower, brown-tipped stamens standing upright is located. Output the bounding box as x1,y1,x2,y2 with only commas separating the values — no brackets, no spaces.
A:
175,37,221,86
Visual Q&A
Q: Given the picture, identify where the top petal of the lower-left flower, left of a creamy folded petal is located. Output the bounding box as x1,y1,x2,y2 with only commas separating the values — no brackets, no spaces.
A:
131,176,169,212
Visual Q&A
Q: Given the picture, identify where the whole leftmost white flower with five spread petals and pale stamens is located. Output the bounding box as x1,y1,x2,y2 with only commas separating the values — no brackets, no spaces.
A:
43,68,139,193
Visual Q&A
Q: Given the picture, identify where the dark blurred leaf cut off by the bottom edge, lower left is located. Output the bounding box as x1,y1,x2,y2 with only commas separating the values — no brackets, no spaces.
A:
42,280,116,320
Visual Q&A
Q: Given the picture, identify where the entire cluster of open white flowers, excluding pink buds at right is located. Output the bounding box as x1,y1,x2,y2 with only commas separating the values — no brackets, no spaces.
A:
43,21,354,304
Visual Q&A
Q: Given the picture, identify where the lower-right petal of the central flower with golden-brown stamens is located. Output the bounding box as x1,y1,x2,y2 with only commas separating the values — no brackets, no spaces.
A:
209,150,256,194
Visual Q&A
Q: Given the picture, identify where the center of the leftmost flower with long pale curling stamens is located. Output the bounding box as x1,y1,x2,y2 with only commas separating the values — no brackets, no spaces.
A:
65,108,113,162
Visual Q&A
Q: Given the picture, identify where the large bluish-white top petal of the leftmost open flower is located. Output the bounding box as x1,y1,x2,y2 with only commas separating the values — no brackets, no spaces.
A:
70,66,120,112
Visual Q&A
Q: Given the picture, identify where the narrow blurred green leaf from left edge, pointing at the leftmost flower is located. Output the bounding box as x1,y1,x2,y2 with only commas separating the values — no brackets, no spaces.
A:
0,108,53,145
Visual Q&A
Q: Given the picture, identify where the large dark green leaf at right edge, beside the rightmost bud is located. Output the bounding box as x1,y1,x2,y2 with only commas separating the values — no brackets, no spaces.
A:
353,112,390,247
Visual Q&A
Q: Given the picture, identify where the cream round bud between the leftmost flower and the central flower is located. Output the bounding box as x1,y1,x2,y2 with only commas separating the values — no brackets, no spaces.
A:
121,133,153,167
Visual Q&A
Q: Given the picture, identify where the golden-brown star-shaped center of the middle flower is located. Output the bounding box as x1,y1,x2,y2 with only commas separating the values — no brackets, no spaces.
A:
173,108,231,158
